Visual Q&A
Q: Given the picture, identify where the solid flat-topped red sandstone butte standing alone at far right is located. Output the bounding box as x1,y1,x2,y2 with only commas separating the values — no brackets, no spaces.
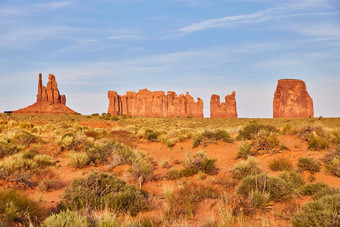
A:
273,79,314,118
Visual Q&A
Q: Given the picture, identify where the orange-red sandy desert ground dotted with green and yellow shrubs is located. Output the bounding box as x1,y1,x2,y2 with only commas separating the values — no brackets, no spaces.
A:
0,114,340,227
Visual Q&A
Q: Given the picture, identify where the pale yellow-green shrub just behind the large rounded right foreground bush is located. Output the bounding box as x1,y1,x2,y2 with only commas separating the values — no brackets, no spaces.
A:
230,157,262,179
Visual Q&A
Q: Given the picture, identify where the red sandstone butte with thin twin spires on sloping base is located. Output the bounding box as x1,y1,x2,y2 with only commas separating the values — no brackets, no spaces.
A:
13,73,77,114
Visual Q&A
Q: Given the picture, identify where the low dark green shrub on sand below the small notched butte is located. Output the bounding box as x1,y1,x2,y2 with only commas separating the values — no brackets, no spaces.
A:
192,129,233,148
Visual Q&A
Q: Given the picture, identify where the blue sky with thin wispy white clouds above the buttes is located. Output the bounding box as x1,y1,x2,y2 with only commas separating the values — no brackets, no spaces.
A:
0,0,340,118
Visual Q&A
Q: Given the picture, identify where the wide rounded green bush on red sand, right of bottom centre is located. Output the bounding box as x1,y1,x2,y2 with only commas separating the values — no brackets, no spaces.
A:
238,174,291,201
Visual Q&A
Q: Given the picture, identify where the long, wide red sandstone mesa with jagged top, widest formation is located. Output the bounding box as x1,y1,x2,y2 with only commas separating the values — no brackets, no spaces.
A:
108,89,203,118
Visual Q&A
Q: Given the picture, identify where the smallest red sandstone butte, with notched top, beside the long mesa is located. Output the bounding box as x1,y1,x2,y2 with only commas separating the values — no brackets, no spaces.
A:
210,91,237,118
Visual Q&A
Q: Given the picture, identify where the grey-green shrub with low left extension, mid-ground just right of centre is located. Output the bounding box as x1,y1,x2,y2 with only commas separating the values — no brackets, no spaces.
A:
168,151,218,180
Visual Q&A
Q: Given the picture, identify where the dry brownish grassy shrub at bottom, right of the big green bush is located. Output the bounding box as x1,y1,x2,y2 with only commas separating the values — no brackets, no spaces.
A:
163,183,219,220
